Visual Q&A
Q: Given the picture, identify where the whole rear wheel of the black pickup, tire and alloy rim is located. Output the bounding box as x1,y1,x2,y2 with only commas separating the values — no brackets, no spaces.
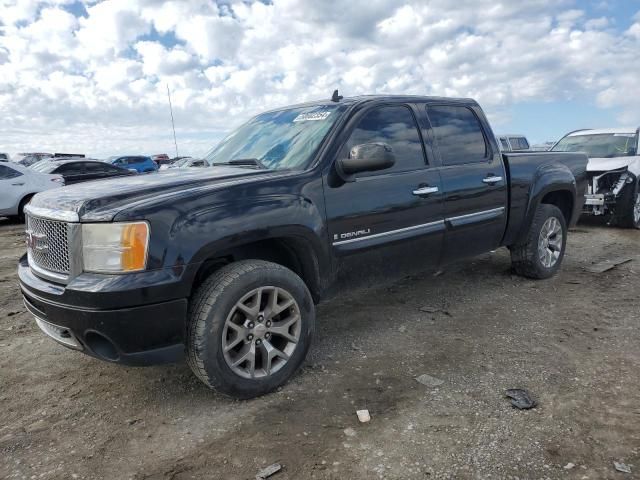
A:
510,204,567,279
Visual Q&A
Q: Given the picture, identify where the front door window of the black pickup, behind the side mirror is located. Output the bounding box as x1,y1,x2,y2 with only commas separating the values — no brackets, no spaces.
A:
340,105,426,175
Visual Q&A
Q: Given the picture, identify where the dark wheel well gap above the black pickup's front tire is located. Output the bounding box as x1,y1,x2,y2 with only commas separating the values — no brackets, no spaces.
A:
192,237,320,302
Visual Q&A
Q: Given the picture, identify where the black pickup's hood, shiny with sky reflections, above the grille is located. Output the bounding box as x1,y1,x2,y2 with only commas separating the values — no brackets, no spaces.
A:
29,167,291,222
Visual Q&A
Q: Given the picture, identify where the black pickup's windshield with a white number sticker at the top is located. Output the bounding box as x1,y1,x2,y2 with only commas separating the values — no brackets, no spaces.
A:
205,105,346,170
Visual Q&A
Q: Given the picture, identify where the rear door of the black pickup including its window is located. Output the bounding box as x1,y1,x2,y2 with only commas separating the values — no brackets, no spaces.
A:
427,104,508,262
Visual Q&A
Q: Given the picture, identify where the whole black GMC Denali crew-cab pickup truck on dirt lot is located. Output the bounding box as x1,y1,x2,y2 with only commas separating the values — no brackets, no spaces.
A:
18,95,587,398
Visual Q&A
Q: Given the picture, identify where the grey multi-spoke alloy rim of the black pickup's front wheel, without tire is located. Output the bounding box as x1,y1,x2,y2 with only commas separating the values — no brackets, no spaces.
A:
222,286,302,379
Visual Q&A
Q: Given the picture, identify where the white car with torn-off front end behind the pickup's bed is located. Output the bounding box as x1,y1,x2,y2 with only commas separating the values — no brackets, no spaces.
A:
551,128,640,228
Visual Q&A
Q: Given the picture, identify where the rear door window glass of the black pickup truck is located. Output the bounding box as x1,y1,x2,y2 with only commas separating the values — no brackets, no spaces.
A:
427,105,488,165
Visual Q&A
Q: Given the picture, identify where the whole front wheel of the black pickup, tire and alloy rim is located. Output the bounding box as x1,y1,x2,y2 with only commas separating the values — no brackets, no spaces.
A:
185,260,315,399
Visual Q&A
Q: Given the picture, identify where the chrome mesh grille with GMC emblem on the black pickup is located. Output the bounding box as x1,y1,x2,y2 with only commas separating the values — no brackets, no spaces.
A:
27,215,70,274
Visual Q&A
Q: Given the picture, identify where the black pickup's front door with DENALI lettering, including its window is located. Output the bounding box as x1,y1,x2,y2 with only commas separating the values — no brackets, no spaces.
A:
325,104,444,286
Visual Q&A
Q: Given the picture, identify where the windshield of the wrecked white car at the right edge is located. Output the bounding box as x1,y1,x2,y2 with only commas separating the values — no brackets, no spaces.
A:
552,133,638,158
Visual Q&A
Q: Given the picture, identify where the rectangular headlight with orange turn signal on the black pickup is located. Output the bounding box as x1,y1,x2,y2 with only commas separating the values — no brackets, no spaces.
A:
82,222,149,273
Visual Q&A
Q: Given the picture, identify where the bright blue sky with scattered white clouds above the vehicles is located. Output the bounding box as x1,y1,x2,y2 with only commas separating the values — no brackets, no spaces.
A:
0,0,640,158
